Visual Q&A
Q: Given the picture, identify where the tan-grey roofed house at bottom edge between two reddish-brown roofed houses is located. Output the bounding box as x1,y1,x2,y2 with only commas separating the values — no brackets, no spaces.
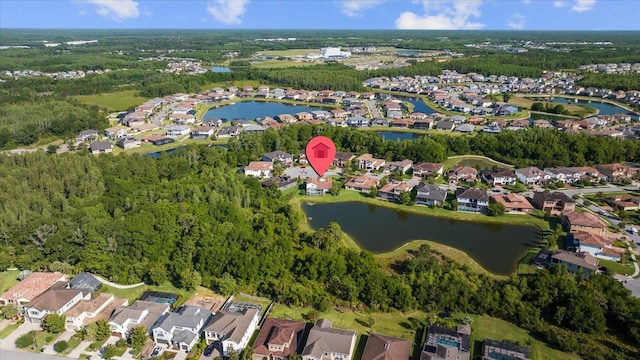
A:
302,319,356,360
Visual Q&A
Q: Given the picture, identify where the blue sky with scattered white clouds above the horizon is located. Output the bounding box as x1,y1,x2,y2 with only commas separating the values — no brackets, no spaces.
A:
0,0,640,30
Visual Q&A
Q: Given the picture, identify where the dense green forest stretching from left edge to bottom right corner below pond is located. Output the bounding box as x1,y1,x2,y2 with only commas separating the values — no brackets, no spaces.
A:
0,139,640,359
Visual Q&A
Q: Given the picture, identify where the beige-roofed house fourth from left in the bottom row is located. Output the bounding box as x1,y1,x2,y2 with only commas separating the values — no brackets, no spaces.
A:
109,300,171,338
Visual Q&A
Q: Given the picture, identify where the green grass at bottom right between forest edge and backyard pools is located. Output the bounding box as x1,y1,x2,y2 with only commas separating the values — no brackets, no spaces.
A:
454,314,579,360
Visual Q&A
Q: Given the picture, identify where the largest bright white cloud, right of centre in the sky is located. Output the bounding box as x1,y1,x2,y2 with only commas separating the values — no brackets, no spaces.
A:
396,0,484,30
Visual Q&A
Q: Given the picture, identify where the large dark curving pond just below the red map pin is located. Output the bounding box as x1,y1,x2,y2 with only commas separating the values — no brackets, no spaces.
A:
302,202,539,275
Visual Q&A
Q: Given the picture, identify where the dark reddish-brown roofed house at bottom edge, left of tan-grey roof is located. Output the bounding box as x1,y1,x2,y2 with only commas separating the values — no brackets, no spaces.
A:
253,318,307,360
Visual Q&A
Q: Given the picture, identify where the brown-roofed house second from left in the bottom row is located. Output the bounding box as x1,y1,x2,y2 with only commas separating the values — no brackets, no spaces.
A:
24,282,91,324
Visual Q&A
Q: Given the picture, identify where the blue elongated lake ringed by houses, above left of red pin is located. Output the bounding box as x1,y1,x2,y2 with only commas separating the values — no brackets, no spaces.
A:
204,101,323,120
